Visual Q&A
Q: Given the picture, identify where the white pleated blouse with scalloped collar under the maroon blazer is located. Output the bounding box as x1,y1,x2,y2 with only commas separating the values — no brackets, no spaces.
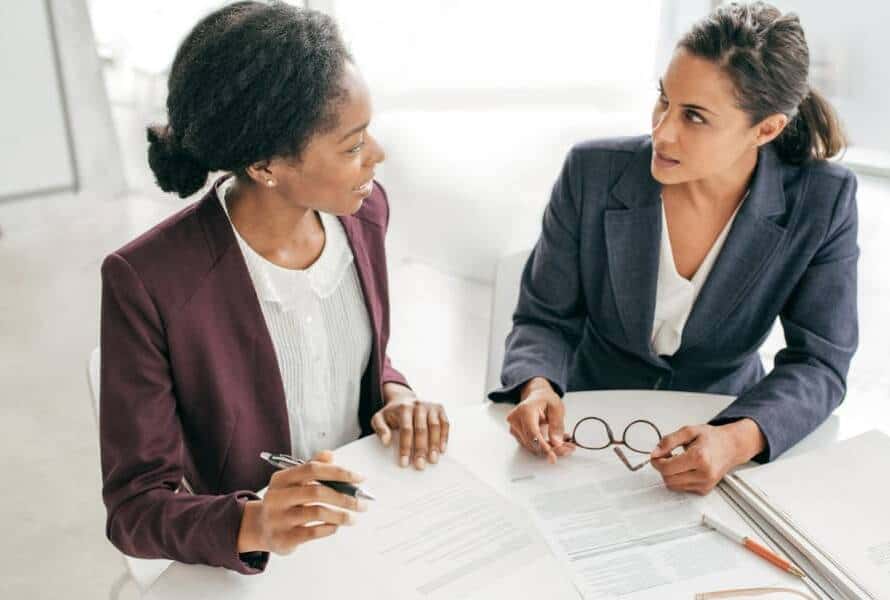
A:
217,177,372,459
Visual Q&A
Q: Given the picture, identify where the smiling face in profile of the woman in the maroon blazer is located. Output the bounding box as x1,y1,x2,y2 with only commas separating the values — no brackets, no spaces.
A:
261,62,385,215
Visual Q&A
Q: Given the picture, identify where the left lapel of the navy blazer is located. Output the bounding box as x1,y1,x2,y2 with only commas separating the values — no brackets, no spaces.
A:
605,143,666,366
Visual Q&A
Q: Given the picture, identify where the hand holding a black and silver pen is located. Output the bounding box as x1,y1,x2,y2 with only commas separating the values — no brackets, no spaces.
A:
238,451,366,554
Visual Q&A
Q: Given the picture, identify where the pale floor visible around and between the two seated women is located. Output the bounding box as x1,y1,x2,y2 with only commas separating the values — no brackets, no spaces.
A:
0,101,890,600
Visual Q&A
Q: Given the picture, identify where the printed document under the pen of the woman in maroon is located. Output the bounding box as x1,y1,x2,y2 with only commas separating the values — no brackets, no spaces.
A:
338,440,547,600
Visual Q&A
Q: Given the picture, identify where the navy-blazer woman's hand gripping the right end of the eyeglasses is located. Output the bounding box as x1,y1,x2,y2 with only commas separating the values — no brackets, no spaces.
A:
651,419,766,496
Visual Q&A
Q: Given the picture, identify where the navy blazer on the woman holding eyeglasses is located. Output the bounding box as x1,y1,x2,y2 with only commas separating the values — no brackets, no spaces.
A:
489,136,859,461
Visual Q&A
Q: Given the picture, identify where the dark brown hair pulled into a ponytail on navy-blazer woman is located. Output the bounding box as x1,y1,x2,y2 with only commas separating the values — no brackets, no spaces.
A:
678,2,846,164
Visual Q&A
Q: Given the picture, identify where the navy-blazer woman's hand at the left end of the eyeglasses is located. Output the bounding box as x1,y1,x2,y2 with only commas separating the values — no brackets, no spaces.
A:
507,377,575,464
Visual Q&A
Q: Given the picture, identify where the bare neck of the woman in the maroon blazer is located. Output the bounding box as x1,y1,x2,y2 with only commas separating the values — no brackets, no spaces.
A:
226,180,318,255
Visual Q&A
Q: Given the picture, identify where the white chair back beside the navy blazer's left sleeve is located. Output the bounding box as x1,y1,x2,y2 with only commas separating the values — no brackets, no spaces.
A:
485,250,531,395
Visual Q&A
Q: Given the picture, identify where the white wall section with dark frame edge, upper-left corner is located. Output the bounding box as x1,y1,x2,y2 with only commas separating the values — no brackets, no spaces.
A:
0,0,125,204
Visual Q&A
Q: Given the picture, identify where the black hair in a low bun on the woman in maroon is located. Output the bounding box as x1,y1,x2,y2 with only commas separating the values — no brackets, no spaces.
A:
148,2,352,198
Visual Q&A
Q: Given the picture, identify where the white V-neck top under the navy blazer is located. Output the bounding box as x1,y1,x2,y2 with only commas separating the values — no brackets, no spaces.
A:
652,195,747,356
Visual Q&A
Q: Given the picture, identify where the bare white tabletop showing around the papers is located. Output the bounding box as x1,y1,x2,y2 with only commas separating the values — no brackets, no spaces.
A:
145,391,890,600
